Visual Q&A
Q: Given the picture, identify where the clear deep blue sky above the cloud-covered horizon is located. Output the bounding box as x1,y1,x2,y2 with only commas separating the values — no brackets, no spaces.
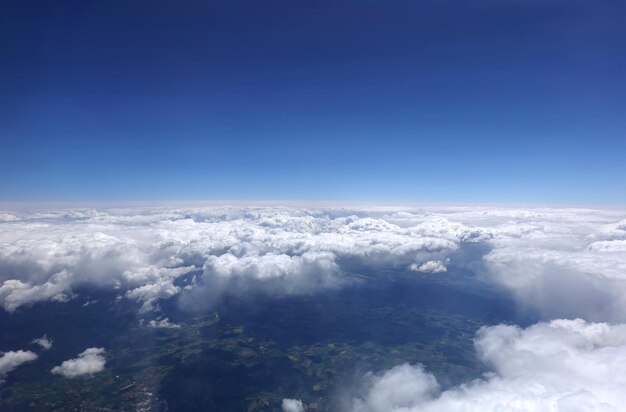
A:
0,0,626,205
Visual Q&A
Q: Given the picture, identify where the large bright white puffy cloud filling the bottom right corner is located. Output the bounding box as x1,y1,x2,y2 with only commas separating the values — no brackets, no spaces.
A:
351,319,626,412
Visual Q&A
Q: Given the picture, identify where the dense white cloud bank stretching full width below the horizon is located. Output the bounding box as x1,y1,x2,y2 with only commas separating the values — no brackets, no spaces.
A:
0,206,626,321
